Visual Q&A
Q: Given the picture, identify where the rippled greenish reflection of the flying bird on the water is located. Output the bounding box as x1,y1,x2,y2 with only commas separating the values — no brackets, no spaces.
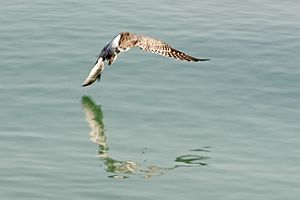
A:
82,96,209,179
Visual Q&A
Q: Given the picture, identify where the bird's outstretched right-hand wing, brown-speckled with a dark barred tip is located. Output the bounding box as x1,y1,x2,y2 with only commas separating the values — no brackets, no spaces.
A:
135,35,209,62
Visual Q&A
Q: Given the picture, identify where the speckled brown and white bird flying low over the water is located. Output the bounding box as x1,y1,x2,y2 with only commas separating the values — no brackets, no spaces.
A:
82,32,210,87
